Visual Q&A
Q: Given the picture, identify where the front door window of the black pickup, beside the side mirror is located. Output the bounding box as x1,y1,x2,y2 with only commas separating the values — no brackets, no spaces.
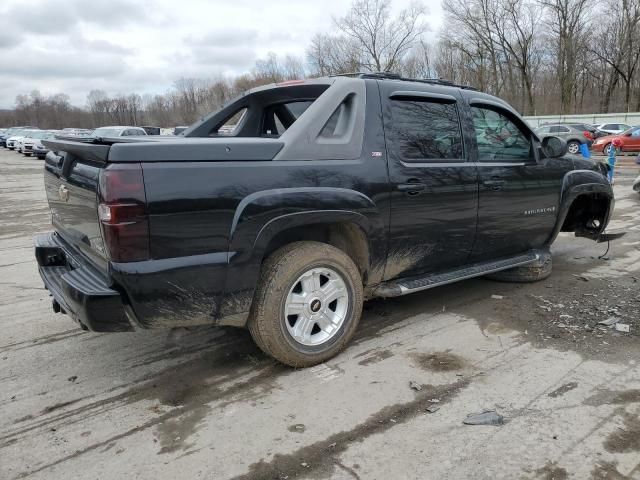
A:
471,107,532,162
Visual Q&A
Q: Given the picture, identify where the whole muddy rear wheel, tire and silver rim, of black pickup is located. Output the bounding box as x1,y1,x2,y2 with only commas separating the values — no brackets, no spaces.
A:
248,242,363,367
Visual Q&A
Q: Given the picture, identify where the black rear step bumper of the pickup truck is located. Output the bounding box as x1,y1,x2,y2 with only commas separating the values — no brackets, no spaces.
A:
34,233,134,332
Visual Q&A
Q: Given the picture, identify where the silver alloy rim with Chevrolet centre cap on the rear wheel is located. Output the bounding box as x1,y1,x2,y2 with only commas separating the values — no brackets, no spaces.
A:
284,267,350,346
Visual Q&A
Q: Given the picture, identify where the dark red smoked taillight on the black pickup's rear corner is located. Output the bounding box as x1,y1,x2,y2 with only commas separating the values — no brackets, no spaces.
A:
98,163,149,262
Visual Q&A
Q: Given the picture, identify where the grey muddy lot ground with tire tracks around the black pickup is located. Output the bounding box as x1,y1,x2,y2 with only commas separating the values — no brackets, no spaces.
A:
0,150,640,480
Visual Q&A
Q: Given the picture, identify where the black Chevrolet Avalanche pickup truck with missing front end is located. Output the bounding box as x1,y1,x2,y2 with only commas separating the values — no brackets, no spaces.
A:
35,74,614,366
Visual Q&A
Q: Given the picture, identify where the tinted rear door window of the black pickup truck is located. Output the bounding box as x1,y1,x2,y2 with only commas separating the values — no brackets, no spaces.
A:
390,99,464,162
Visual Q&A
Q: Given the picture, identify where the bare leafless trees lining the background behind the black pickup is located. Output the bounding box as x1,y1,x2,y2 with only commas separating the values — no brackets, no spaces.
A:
0,0,640,128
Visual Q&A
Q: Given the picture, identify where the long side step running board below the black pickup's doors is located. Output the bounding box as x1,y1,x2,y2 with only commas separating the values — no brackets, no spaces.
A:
374,252,540,297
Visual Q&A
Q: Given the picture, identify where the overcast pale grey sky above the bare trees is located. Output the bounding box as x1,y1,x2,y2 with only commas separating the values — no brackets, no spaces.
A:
0,0,441,108
